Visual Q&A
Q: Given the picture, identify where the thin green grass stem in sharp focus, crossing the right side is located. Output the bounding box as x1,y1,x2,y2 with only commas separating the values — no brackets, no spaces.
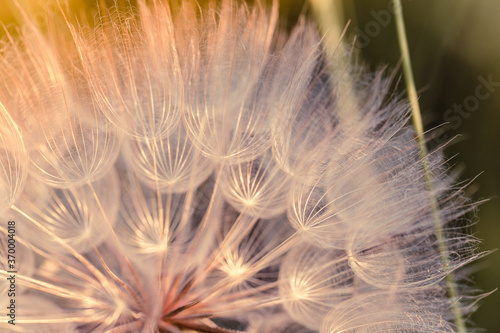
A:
392,0,466,333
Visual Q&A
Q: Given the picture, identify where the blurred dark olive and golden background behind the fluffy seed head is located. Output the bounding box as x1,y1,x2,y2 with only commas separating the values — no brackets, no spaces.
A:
0,0,500,333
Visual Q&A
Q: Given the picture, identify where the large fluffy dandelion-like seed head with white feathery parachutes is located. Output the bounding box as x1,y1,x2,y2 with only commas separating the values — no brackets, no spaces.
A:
0,0,482,333
